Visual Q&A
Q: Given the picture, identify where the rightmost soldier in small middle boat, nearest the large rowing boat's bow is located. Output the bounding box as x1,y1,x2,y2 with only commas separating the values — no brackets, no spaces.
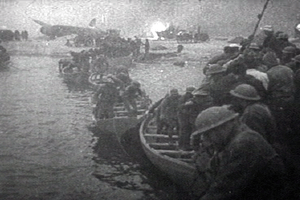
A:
121,81,143,117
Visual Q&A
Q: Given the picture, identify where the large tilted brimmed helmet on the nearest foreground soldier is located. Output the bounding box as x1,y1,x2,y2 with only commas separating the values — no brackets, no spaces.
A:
195,106,239,134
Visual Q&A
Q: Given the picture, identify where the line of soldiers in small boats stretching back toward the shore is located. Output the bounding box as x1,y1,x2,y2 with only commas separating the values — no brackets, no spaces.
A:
59,38,149,119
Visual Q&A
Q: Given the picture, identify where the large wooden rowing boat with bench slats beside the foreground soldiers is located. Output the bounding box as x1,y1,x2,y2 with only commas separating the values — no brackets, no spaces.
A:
139,113,204,195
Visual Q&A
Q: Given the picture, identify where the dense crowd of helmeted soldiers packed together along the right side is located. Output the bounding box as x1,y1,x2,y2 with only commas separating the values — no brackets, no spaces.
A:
149,26,300,200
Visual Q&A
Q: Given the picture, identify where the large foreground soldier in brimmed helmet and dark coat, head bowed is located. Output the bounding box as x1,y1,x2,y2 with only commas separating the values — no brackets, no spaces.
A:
191,106,284,200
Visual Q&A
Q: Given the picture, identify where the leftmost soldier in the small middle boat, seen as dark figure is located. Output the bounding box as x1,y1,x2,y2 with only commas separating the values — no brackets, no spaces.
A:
93,77,118,119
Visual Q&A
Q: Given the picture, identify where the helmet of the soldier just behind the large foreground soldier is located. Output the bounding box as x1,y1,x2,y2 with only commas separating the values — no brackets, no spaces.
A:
230,84,260,101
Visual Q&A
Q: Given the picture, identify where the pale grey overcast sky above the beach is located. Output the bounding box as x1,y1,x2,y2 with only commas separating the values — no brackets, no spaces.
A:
0,0,300,36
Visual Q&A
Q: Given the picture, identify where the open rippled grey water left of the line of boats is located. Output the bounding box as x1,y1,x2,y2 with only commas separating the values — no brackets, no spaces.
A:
0,56,188,200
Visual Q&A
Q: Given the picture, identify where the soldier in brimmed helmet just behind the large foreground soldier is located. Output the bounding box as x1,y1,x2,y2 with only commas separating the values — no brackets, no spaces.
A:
230,84,278,144
